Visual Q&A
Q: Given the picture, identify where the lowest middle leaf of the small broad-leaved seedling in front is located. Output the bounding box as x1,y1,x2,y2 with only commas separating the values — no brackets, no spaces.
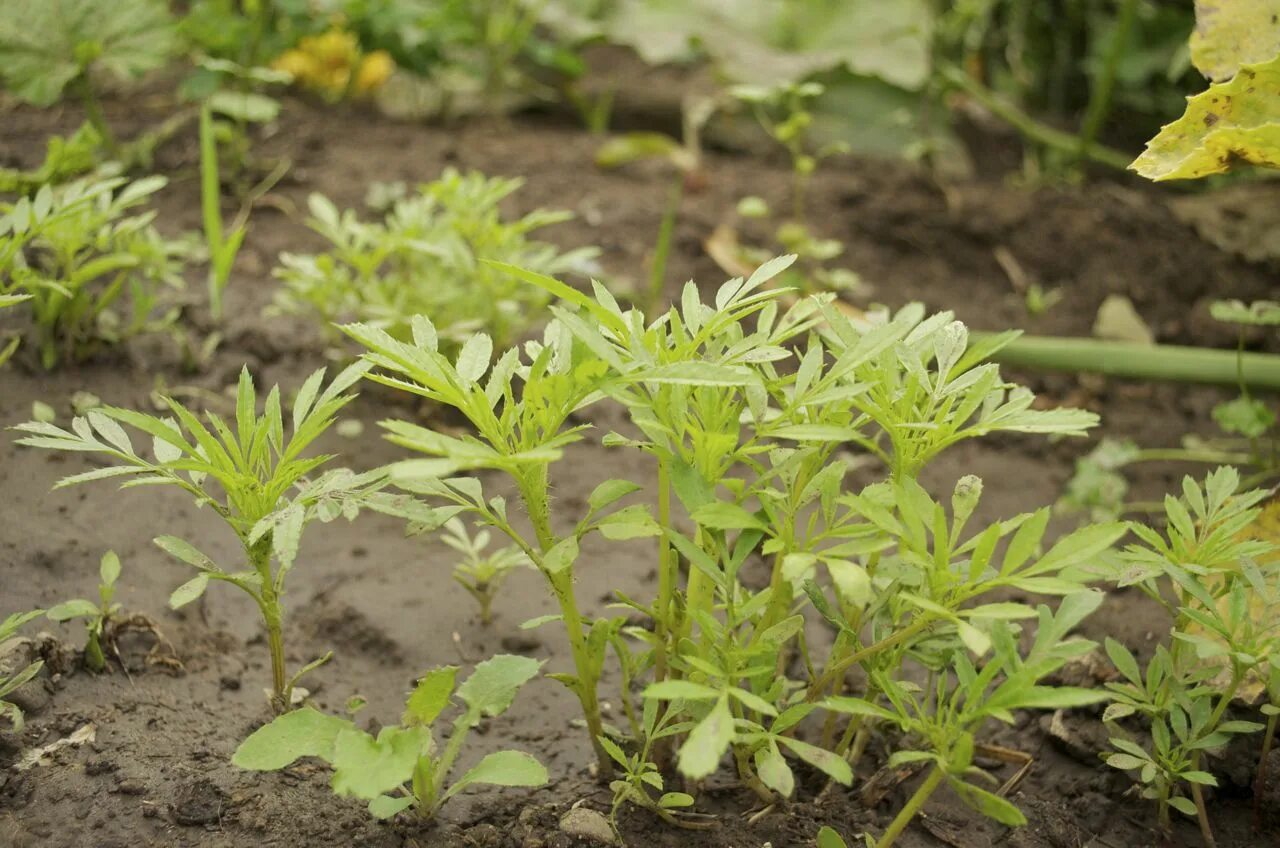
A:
332,728,431,801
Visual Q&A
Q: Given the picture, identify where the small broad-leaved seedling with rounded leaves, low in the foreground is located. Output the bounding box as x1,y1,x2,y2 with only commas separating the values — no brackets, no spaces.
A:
232,655,547,819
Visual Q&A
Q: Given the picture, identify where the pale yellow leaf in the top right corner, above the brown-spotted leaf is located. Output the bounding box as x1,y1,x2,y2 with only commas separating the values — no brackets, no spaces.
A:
1192,0,1280,82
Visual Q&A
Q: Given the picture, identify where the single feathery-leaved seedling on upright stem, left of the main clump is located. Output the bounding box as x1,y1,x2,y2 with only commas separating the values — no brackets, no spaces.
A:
14,365,431,710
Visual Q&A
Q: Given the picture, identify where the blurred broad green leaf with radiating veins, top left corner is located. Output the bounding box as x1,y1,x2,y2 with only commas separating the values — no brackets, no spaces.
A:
0,0,175,106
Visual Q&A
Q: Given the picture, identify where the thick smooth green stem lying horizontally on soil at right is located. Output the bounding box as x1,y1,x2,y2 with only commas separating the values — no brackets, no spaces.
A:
972,333,1280,389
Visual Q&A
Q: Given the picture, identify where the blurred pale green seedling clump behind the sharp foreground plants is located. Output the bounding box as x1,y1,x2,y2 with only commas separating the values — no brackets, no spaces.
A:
276,169,595,350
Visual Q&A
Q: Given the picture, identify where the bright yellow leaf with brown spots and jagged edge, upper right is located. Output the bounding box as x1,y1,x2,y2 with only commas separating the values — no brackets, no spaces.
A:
1130,56,1280,181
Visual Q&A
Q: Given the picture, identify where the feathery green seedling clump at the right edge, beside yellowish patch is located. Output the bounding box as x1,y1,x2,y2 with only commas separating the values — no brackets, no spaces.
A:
1105,468,1280,826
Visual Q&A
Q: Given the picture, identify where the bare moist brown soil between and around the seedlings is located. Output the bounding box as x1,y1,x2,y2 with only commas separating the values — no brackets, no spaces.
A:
0,87,1280,848
